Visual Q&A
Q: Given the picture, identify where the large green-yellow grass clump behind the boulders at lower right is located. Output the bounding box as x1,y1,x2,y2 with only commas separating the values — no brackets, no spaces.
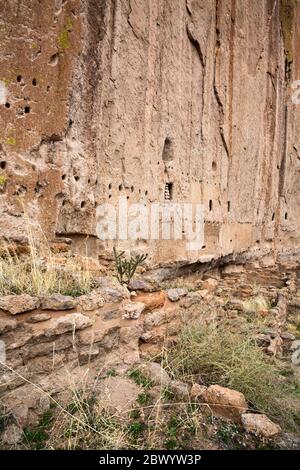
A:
166,324,299,429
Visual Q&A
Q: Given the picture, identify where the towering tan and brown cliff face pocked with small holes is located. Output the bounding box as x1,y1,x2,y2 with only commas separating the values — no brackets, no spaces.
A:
0,0,300,262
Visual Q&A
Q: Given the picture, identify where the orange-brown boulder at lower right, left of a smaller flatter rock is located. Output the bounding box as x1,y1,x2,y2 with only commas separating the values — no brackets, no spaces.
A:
203,385,248,422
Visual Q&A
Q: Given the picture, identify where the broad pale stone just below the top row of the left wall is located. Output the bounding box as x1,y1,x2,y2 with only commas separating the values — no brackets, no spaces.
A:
45,313,94,337
